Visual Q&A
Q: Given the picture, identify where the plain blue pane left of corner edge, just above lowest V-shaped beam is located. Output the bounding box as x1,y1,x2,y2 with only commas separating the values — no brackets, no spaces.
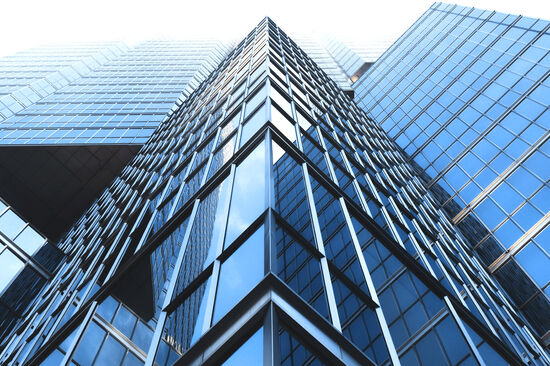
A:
214,226,264,322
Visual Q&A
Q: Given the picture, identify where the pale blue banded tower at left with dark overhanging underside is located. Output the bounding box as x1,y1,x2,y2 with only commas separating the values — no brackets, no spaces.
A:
0,40,228,240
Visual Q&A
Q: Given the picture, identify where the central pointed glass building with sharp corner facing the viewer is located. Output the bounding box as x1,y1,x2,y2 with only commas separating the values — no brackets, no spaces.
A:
0,18,550,365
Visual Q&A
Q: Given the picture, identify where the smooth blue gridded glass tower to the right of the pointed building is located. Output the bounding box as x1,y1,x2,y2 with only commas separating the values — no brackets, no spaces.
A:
354,3,550,344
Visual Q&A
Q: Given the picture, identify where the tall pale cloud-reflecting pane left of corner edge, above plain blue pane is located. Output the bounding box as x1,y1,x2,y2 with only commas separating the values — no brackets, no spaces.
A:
225,142,265,247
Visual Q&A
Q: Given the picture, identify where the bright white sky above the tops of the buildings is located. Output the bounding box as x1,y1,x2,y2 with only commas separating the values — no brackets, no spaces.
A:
0,0,550,56
